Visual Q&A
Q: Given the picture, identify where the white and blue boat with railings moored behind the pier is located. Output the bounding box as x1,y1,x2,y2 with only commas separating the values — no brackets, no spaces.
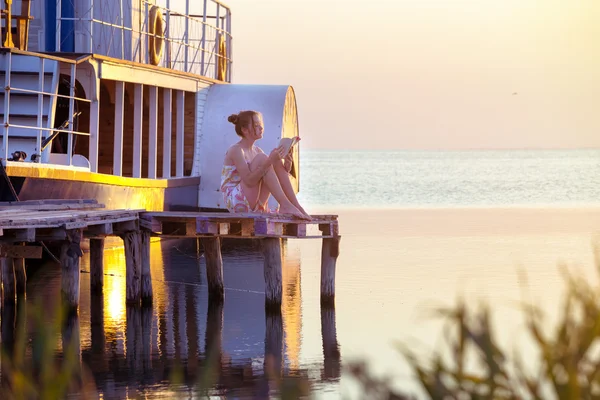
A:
0,0,299,211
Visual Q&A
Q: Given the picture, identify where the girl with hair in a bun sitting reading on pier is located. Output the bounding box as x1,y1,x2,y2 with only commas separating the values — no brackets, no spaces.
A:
221,111,311,220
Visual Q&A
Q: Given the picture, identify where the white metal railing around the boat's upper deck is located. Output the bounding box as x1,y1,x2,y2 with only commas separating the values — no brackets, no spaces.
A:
56,0,233,82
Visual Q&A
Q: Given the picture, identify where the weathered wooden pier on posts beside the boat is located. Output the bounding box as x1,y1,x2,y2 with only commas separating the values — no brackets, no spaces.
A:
0,200,340,309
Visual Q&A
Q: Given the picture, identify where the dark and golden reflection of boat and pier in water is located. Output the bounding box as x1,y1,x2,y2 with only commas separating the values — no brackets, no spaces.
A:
7,241,340,398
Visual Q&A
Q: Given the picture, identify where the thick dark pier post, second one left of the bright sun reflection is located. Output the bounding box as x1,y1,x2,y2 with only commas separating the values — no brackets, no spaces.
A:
60,229,83,311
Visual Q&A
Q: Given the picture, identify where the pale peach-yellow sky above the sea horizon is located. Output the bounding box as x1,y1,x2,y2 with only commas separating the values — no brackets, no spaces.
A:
225,0,600,149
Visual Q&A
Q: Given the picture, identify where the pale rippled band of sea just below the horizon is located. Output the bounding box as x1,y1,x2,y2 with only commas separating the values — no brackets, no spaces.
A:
300,150,600,208
